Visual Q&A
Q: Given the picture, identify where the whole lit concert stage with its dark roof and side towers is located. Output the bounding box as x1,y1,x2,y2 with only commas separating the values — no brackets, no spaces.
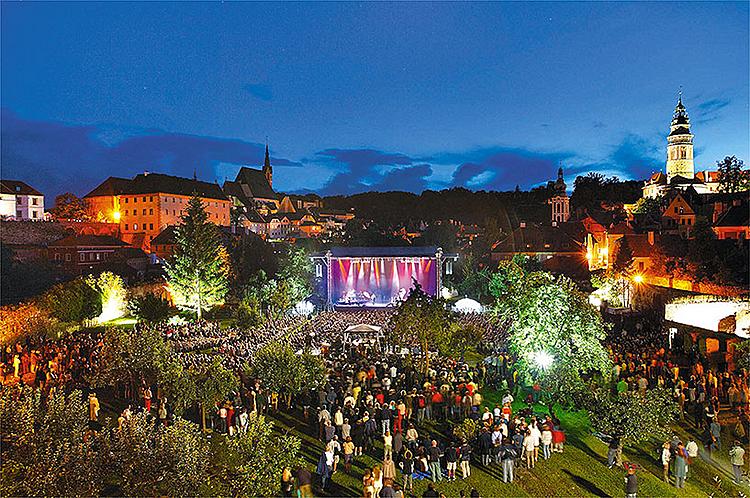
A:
311,246,458,309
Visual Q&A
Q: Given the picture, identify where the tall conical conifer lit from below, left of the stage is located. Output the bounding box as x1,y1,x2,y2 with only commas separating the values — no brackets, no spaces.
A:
165,194,229,320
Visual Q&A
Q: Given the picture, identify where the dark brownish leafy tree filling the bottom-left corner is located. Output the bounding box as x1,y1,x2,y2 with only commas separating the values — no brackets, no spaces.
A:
0,386,103,496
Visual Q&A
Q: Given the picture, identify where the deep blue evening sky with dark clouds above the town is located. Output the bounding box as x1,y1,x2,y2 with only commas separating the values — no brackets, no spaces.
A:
0,2,750,196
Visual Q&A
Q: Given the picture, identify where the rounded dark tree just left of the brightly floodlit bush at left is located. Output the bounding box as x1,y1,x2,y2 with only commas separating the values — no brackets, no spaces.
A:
42,278,102,322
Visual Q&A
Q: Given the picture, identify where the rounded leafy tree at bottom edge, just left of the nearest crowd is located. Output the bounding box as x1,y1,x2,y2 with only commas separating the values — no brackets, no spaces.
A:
209,414,302,496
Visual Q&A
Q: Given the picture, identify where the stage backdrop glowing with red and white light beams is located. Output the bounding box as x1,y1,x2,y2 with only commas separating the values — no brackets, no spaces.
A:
331,257,437,306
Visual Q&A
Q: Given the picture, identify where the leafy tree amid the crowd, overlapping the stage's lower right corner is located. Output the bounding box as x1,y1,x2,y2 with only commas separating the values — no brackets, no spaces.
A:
392,281,451,372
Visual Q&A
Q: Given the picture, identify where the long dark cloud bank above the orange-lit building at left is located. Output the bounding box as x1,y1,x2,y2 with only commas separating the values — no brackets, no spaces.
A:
0,109,301,198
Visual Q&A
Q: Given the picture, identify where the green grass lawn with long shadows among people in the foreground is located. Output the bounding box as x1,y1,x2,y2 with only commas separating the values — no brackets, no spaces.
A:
272,392,746,498
